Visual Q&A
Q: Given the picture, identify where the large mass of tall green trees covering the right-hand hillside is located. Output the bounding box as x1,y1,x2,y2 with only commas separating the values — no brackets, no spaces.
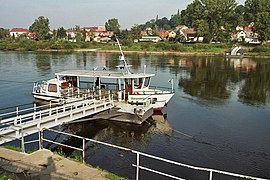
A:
139,0,270,42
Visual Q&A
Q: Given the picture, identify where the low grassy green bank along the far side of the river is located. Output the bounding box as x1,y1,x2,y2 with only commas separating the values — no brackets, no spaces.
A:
0,39,270,56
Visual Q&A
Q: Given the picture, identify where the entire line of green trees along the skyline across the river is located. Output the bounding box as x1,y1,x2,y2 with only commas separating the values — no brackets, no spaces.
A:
0,0,270,44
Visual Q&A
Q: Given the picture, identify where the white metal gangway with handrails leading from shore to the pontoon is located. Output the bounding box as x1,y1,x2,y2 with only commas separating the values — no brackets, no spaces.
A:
0,94,114,144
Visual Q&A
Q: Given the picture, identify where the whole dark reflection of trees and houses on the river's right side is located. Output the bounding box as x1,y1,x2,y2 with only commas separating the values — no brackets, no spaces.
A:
174,57,270,105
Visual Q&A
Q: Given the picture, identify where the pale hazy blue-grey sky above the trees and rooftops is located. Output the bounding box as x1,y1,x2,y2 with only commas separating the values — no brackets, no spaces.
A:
0,0,245,29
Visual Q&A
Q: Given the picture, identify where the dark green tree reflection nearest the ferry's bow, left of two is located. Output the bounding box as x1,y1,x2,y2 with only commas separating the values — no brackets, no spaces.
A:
179,58,235,102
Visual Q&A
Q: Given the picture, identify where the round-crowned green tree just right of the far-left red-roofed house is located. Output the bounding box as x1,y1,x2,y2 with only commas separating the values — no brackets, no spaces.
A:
29,16,50,40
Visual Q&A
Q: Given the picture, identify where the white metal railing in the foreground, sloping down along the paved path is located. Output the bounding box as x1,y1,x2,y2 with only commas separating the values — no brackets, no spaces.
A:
24,128,267,180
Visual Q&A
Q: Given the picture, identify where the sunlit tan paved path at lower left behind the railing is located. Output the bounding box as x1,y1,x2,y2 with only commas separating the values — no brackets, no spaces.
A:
0,147,107,180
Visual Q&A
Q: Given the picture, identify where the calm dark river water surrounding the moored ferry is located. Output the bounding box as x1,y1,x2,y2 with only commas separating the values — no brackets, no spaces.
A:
0,51,270,179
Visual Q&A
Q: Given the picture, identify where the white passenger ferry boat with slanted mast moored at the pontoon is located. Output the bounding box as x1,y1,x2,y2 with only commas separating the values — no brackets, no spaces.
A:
32,40,174,110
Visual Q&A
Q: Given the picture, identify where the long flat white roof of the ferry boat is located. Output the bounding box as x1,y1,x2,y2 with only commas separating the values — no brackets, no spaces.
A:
55,70,155,79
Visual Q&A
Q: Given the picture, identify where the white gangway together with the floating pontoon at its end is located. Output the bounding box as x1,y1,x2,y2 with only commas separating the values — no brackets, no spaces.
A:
0,94,153,144
